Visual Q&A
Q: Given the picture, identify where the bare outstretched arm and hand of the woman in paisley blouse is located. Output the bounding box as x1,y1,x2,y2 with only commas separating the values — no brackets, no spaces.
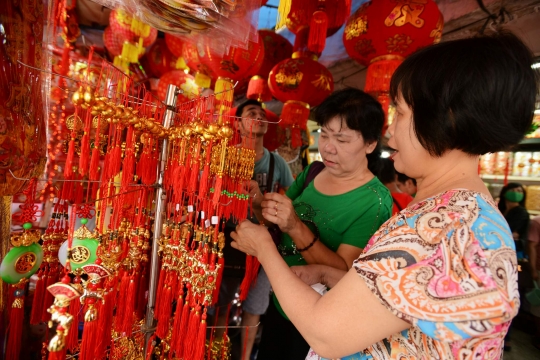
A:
231,221,410,358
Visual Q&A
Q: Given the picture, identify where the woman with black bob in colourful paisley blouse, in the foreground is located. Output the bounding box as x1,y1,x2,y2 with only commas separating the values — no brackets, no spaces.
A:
233,33,537,359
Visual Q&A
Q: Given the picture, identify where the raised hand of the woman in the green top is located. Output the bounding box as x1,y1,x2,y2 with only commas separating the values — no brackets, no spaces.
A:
261,193,301,233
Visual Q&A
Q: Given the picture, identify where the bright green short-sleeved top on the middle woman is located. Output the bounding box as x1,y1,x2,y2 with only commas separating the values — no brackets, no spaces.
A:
274,166,393,316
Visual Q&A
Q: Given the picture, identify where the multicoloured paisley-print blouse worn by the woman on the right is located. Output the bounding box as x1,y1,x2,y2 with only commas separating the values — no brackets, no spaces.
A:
308,190,519,360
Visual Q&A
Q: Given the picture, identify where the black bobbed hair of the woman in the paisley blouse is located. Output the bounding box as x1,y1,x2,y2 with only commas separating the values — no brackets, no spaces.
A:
390,32,537,156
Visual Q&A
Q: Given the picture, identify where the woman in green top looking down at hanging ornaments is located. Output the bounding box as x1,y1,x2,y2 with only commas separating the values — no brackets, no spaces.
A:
247,89,392,360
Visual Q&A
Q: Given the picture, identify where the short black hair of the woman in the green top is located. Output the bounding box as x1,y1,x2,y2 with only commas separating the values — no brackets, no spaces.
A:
315,88,385,174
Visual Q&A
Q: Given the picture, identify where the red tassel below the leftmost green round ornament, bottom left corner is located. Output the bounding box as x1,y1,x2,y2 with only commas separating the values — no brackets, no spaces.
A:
6,283,24,360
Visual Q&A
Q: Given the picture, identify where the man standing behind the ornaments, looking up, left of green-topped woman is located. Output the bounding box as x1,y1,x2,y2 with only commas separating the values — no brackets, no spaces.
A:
218,100,294,359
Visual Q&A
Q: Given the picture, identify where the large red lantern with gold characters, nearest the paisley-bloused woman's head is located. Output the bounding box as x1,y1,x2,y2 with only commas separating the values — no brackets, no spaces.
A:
343,0,444,125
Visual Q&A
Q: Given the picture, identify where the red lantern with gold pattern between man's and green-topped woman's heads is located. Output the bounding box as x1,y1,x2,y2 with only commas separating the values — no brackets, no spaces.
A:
268,56,334,147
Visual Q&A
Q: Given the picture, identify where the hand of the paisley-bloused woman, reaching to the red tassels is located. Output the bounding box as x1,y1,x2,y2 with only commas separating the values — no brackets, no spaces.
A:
231,220,276,257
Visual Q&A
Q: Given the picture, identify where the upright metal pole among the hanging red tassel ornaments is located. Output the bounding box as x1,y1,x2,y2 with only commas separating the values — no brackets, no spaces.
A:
143,84,179,358
